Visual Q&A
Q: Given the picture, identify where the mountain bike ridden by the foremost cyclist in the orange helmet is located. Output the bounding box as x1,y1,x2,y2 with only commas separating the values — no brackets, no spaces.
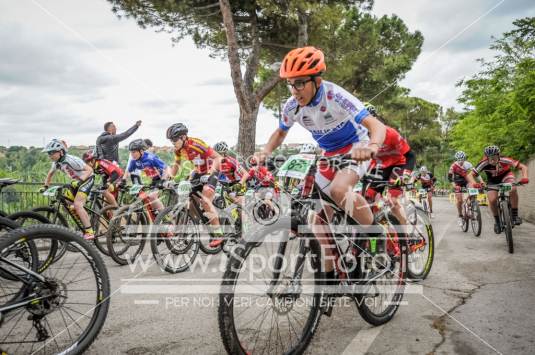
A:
218,156,406,354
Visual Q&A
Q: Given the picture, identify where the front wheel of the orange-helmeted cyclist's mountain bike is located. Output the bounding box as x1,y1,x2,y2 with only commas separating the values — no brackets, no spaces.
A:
218,219,323,354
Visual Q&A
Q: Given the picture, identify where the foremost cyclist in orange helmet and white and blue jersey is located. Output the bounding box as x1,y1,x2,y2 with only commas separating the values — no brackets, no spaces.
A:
259,46,386,277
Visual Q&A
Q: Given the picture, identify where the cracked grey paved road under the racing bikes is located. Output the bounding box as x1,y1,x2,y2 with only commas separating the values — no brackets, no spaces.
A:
89,199,535,354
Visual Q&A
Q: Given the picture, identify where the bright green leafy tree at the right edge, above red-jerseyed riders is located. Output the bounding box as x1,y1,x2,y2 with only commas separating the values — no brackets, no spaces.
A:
452,17,535,159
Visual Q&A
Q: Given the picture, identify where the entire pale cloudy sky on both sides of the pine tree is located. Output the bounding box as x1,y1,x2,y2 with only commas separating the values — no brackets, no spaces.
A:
0,0,535,146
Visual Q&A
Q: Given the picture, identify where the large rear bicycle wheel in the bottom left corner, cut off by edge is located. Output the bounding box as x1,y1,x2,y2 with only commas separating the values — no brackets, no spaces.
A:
0,224,110,354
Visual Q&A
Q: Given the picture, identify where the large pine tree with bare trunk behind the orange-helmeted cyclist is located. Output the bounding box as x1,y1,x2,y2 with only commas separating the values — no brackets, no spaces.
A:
109,0,423,155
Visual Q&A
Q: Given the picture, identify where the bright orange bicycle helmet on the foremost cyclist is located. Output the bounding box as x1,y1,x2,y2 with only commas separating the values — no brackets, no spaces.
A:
279,47,327,79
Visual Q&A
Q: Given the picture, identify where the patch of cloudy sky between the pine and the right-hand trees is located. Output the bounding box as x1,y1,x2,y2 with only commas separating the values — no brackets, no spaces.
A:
372,0,535,109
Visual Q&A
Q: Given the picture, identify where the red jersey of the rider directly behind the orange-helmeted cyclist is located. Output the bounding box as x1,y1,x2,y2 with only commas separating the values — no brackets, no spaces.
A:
370,126,411,169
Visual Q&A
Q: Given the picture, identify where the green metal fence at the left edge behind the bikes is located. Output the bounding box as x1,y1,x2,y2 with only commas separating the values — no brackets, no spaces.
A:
0,182,49,214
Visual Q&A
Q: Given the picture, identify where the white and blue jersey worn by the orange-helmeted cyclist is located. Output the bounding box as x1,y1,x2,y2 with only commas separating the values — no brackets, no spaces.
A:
279,81,369,152
